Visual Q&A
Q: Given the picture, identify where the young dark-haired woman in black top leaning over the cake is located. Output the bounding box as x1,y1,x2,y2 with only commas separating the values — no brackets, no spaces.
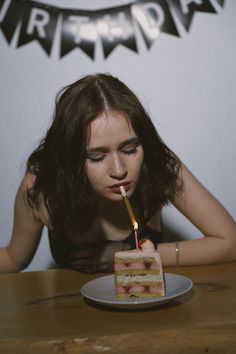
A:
0,74,236,272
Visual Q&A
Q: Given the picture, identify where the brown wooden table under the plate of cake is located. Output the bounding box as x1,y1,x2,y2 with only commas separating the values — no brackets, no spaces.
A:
0,262,236,354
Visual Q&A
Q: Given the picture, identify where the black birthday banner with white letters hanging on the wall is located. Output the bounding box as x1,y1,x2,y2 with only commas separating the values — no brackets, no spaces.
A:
0,0,225,59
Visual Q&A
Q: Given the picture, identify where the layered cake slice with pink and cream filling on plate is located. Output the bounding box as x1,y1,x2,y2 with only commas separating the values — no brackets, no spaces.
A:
114,240,165,299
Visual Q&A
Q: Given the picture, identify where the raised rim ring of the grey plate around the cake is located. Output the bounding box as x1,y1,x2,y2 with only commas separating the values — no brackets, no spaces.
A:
81,272,193,308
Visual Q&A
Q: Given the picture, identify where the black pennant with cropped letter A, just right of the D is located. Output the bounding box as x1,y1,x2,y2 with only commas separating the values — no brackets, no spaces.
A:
168,0,216,31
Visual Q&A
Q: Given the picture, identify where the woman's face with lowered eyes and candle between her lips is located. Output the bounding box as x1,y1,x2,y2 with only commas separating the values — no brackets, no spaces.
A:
85,112,144,201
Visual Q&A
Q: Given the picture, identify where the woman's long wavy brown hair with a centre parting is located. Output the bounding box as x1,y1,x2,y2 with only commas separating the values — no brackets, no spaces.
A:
27,73,180,233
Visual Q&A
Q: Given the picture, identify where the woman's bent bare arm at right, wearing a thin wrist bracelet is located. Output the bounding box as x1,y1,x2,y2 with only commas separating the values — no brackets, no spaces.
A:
159,165,236,265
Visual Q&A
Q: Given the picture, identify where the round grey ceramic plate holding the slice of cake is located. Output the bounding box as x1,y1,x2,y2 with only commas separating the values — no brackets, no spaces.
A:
81,273,193,309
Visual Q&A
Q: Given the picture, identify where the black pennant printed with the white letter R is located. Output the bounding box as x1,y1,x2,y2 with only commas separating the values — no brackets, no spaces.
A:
17,1,58,55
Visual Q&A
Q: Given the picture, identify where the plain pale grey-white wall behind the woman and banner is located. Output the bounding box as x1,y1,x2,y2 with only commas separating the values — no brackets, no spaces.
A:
0,0,236,270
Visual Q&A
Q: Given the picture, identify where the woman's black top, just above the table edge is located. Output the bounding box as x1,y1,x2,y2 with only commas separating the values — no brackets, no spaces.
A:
49,225,163,273
